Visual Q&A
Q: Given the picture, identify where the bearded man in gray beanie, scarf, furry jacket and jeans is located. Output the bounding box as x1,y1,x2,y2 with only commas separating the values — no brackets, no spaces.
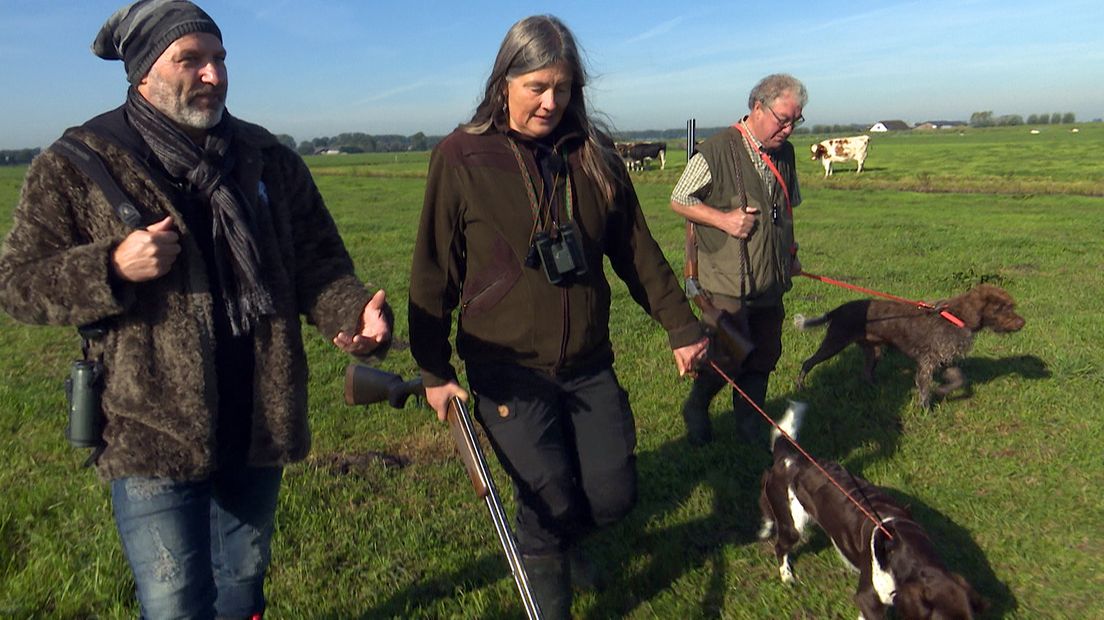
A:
0,0,392,619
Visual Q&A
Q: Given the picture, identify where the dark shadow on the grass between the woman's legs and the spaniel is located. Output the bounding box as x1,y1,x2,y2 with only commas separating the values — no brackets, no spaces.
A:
584,391,786,620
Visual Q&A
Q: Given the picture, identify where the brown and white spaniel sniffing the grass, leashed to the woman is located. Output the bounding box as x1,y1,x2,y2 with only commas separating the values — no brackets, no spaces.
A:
760,402,987,620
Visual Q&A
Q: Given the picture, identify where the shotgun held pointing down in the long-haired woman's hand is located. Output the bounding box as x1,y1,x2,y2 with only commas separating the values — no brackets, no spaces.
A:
344,364,541,620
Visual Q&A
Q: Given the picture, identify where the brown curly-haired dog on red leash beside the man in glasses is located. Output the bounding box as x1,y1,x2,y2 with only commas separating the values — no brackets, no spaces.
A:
794,285,1023,409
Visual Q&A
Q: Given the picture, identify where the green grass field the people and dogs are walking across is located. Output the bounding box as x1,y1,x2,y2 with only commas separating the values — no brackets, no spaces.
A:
0,124,1104,619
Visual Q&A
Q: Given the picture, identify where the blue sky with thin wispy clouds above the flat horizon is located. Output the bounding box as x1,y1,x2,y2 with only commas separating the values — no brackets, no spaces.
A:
0,0,1104,149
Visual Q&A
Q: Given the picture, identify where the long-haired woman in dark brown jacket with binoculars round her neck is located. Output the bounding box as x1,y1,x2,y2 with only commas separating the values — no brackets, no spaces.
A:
410,15,705,618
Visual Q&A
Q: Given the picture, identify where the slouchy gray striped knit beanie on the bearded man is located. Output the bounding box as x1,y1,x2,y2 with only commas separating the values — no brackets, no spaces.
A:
92,0,222,84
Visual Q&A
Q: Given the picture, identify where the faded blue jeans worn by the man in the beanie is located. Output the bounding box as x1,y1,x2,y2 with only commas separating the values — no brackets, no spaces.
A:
112,467,284,619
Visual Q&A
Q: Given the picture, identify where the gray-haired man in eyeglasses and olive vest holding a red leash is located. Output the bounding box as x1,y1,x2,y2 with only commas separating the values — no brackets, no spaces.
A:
671,74,808,446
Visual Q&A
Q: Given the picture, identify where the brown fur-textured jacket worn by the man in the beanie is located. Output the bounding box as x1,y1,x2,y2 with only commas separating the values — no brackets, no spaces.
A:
0,108,370,480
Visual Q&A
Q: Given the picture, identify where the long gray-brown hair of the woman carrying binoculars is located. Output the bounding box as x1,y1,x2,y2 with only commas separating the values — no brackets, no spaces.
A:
460,15,617,201
